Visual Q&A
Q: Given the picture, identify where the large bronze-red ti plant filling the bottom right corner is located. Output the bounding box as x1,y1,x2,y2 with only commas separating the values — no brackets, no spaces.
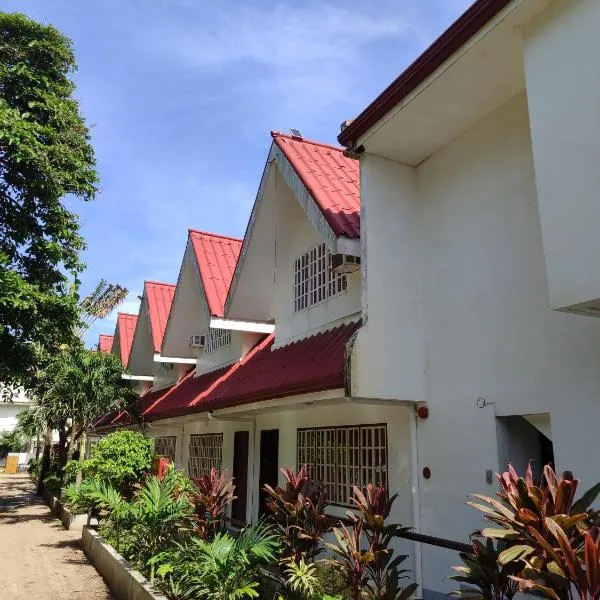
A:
454,465,600,600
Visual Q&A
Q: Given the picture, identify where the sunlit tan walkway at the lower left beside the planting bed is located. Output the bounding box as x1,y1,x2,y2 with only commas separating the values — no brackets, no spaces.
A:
0,474,114,600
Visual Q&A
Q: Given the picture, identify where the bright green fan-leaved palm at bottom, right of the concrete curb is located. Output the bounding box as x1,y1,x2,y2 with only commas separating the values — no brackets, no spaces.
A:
153,522,279,600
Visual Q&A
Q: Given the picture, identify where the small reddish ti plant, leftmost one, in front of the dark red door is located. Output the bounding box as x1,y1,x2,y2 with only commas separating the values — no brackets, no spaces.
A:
190,467,236,539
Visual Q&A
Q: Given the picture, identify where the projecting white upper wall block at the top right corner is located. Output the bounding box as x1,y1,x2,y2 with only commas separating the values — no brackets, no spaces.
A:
524,0,600,316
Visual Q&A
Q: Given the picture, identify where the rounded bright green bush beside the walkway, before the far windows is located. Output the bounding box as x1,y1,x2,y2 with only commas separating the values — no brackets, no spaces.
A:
76,429,154,497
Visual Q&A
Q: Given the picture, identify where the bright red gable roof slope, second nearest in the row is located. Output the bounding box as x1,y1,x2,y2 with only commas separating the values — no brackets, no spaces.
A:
189,229,242,317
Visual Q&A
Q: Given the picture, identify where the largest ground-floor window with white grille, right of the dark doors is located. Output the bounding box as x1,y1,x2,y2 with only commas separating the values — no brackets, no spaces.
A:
297,425,387,506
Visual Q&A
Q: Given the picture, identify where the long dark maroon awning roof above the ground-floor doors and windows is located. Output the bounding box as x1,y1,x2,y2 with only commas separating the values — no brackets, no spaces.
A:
144,323,359,420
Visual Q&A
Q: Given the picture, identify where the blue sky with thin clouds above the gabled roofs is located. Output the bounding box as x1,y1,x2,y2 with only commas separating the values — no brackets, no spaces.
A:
2,0,470,345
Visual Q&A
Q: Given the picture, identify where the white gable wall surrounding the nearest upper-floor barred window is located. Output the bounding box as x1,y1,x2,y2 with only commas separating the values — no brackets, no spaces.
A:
274,171,361,345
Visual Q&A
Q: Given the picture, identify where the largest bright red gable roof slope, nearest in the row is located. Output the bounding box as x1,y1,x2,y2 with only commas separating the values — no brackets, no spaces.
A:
271,131,360,238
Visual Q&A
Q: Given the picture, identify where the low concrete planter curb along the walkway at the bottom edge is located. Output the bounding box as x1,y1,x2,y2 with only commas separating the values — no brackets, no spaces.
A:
81,526,167,600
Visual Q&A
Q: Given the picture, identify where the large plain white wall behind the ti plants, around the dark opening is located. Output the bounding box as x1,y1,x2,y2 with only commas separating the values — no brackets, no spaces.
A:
353,94,600,591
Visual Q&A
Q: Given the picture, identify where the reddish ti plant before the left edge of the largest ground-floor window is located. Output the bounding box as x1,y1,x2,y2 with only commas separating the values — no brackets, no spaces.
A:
265,465,333,564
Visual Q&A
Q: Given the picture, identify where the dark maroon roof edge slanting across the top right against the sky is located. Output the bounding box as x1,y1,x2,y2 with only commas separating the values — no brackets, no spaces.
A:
338,0,510,147
